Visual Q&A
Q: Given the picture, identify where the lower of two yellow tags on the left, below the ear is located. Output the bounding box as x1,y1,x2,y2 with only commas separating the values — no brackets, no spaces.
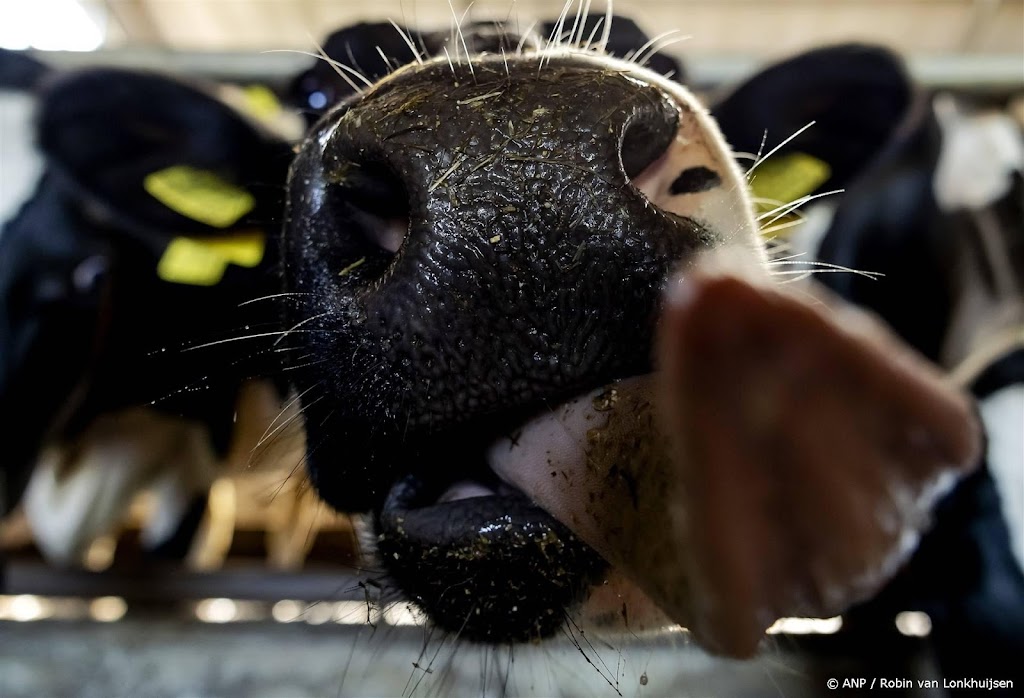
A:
157,232,266,286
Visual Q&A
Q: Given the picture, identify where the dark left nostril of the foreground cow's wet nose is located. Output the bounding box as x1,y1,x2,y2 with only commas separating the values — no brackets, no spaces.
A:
330,163,409,256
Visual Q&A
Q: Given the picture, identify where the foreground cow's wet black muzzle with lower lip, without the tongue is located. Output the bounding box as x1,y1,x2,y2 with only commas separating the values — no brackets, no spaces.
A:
285,44,762,638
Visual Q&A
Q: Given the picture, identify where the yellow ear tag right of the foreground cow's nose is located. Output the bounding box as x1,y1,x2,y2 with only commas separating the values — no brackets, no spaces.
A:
751,152,831,237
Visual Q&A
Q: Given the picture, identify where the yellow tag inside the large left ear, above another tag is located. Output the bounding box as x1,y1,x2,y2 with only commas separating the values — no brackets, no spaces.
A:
142,165,256,228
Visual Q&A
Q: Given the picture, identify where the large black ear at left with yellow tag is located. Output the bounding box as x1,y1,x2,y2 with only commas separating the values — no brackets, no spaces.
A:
37,69,292,241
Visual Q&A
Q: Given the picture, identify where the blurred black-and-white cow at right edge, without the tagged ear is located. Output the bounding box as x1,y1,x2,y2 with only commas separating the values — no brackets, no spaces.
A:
806,84,1024,675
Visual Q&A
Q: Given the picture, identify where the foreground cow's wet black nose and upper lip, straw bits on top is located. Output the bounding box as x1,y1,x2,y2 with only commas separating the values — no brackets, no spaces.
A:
284,55,713,510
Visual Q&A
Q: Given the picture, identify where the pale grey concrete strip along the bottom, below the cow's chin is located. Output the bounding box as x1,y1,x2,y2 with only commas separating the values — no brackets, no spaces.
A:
0,617,945,698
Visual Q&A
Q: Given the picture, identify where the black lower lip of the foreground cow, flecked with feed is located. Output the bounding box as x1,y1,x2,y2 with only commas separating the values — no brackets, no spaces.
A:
375,403,607,643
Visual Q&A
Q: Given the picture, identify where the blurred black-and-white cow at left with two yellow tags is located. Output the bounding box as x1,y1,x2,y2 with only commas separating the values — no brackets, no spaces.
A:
0,59,292,563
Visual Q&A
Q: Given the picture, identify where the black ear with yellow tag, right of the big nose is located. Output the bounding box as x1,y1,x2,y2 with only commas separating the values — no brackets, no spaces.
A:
711,44,919,202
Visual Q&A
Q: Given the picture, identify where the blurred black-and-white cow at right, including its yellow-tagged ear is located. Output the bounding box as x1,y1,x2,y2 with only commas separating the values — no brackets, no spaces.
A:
713,42,1024,675
